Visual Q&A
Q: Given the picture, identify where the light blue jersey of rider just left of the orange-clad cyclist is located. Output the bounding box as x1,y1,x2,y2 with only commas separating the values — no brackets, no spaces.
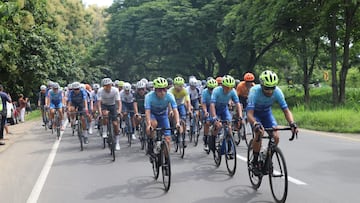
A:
211,86,239,112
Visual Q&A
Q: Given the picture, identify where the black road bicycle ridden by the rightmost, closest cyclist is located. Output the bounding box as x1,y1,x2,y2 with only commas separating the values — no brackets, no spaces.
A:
247,127,297,203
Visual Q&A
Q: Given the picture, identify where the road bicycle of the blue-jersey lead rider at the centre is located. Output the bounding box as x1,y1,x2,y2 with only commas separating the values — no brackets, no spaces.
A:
148,128,174,192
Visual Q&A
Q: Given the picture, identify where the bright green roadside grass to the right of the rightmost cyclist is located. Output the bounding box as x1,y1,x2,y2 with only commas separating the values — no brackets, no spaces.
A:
273,107,360,133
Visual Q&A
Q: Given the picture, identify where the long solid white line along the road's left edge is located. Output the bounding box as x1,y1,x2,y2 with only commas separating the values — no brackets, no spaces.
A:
26,119,68,203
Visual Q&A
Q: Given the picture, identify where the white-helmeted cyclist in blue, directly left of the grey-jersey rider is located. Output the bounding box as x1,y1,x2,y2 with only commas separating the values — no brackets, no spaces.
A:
68,82,89,144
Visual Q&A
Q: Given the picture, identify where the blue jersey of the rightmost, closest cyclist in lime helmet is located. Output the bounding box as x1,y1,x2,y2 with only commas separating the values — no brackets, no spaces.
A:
247,85,288,111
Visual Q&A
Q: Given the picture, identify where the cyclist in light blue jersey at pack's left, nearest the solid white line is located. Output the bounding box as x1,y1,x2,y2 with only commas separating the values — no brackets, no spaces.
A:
46,83,65,131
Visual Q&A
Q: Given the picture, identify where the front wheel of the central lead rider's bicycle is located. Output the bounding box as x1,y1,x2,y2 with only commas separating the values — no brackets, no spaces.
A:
161,142,171,192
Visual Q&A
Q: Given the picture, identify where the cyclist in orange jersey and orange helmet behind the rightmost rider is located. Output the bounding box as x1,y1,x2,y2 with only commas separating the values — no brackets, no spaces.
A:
236,73,255,109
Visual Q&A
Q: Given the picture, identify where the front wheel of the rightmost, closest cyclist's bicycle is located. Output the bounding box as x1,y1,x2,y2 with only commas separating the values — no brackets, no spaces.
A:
268,147,288,202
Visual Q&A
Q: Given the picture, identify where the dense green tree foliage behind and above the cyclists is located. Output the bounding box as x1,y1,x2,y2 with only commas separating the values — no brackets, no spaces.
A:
0,0,360,108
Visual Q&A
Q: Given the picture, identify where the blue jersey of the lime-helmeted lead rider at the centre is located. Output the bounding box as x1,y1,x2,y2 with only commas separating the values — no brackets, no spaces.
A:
145,91,177,115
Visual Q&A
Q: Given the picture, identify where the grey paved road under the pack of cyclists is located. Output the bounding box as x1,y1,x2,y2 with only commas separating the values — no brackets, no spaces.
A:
0,121,360,203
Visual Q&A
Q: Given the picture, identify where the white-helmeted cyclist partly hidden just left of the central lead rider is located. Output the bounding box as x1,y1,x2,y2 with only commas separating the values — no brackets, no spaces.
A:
134,80,147,136
